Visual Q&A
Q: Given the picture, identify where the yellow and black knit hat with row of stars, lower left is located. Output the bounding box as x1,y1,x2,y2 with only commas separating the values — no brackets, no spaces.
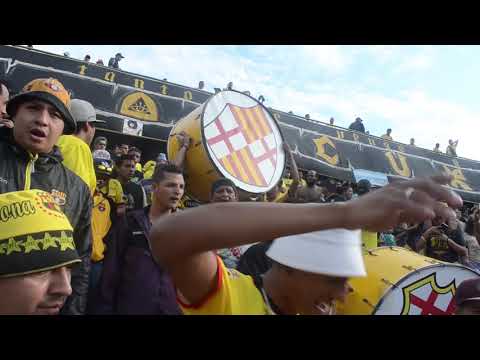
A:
0,190,80,278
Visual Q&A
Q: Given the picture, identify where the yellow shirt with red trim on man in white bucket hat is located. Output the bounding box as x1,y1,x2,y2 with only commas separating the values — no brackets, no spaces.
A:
178,256,273,315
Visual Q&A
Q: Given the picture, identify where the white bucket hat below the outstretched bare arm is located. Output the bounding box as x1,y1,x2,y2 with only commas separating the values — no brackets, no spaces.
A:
267,229,367,277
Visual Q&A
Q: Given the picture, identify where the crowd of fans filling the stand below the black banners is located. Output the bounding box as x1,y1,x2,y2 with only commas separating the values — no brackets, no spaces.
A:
0,75,480,315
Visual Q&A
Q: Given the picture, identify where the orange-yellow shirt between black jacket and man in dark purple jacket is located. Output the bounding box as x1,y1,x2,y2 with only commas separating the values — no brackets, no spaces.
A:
91,191,112,262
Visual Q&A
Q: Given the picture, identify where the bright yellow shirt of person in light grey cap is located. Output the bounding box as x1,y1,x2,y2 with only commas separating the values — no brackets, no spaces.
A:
57,135,97,196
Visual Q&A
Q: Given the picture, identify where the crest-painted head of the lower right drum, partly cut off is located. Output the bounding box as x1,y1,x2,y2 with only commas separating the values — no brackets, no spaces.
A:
373,264,479,315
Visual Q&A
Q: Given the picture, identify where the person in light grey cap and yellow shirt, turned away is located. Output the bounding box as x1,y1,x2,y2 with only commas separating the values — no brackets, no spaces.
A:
57,99,105,195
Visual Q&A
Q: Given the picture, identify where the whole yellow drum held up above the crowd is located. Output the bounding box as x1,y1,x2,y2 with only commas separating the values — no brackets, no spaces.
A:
167,90,285,202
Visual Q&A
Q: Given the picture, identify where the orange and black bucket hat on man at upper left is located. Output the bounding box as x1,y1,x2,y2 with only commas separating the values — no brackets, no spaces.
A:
7,78,76,135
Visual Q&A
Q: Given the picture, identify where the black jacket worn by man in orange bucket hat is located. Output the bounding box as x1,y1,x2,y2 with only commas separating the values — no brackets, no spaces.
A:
0,128,92,315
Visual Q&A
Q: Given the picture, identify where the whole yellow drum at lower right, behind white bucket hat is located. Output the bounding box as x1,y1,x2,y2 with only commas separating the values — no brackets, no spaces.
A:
337,247,480,315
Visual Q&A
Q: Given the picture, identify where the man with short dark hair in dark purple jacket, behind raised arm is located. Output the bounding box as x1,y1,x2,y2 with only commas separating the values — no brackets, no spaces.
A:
89,164,185,315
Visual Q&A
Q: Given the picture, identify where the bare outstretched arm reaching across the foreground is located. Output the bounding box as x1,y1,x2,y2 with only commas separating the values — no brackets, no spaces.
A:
150,176,462,304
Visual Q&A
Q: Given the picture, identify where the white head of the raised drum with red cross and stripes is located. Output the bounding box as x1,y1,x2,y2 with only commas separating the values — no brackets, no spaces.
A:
202,91,285,194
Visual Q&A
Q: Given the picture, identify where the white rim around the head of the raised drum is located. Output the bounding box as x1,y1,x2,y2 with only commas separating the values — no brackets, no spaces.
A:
200,90,286,194
